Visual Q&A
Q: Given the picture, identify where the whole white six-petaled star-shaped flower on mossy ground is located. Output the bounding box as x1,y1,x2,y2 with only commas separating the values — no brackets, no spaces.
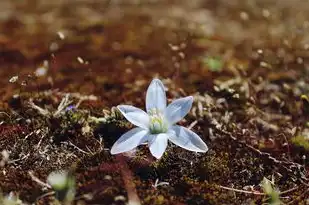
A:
111,79,208,159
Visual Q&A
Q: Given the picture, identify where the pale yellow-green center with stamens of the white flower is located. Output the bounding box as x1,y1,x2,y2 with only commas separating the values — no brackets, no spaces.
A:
149,108,168,134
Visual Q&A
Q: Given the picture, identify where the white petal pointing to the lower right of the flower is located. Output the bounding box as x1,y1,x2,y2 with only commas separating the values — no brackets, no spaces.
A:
168,125,208,152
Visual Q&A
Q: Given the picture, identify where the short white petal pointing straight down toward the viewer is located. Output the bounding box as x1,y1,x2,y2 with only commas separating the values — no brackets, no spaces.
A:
149,133,168,159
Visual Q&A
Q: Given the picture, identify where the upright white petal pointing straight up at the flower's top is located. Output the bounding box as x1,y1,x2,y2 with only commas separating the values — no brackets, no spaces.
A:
146,79,166,113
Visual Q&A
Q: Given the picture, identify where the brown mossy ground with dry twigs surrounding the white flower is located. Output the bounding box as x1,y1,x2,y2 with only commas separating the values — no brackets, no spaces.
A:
0,0,309,204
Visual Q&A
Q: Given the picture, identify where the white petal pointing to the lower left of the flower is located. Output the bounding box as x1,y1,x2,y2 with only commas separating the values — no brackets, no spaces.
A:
111,127,148,154
